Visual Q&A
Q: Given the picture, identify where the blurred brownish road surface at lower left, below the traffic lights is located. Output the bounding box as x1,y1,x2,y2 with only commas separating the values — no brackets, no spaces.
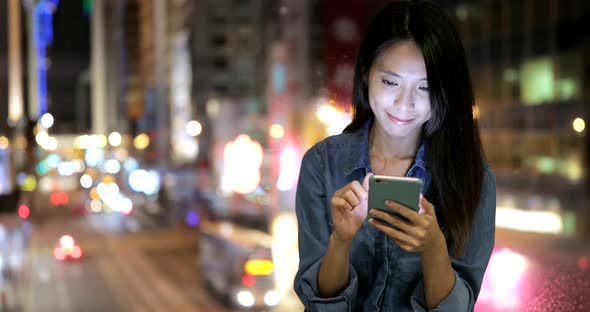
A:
22,214,301,312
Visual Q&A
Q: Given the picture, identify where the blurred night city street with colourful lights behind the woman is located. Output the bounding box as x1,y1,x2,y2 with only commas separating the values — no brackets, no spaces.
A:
0,0,590,312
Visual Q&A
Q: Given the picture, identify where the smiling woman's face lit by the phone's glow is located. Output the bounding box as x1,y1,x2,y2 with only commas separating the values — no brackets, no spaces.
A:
368,41,430,138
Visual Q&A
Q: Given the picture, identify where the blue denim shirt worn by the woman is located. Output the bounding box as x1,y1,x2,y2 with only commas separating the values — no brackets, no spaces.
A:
294,120,496,312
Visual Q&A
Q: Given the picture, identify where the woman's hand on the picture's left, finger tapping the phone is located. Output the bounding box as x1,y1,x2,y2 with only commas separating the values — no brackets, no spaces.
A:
332,173,373,243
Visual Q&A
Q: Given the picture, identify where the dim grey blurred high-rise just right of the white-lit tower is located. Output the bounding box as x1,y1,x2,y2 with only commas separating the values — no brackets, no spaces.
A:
189,0,277,169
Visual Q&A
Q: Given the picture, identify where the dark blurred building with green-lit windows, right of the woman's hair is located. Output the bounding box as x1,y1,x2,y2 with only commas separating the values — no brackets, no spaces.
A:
445,0,590,237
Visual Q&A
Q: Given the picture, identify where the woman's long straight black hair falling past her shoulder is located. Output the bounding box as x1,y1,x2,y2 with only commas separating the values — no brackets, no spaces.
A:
344,0,484,255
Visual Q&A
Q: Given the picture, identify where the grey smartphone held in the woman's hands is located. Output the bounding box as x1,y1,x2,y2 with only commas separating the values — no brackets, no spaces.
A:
367,175,422,220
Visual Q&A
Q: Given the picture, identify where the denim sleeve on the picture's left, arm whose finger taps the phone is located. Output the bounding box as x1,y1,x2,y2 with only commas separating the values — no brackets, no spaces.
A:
294,143,358,312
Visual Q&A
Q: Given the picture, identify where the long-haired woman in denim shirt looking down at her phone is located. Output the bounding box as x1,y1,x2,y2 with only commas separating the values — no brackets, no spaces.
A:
295,1,496,312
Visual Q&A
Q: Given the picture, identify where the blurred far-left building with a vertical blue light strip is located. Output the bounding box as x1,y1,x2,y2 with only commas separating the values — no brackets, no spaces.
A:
0,0,90,134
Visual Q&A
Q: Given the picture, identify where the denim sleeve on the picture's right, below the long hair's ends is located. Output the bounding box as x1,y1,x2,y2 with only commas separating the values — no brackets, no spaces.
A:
411,167,496,312
